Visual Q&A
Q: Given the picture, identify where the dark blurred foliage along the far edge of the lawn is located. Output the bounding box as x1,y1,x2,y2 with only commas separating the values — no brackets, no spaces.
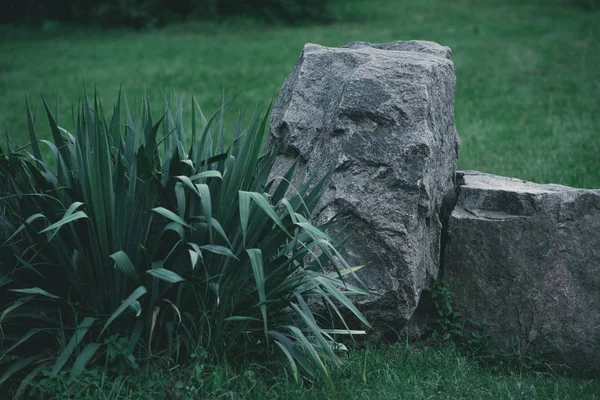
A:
0,0,332,28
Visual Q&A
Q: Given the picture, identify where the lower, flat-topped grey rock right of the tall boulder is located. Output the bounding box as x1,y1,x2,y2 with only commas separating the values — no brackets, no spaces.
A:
443,171,600,376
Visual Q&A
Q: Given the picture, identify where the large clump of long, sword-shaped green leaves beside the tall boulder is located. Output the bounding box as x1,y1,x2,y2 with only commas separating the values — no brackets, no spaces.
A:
0,93,368,390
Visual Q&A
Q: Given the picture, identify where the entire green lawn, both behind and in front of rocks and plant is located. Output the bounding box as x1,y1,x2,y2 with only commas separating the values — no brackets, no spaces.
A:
0,0,600,400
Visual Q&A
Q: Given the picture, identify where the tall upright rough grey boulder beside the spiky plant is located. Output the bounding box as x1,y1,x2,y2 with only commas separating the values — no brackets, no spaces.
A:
270,41,459,334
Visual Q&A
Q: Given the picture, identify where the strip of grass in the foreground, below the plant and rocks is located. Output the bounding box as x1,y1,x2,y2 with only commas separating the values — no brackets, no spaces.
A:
22,344,600,400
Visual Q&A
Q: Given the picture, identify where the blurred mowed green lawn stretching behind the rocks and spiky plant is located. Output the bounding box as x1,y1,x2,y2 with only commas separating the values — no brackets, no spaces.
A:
0,0,600,188
